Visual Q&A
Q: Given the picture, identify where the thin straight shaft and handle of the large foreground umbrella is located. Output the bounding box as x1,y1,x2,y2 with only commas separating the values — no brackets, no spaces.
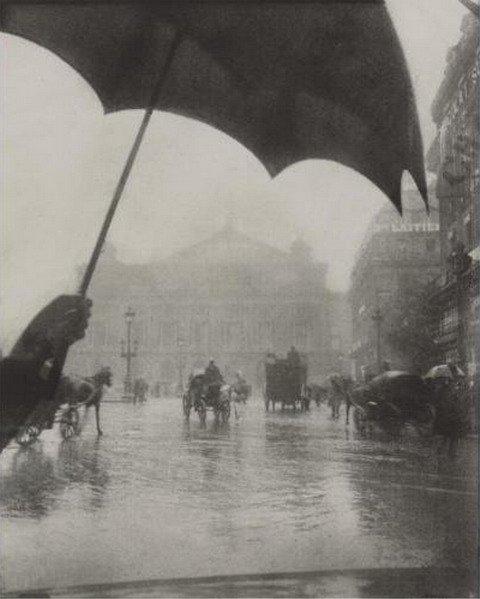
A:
48,29,182,399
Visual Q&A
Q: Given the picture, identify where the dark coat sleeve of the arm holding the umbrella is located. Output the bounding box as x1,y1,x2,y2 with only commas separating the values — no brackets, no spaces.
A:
0,358,48,451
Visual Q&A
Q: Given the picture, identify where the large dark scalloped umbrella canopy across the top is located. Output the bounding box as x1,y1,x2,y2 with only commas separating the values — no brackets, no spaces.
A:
0,0,426,209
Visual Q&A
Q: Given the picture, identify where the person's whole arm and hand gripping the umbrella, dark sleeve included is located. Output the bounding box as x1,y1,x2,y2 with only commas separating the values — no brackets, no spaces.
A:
0,295,91,451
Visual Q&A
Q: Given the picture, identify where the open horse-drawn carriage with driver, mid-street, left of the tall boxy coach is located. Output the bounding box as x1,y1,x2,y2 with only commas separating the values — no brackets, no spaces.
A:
182,373,230,423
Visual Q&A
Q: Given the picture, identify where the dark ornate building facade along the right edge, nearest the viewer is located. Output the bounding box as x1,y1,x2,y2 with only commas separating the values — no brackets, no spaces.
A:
428,14,480,374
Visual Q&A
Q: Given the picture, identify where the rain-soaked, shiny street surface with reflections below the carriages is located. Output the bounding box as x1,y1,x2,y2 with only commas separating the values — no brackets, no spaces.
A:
0,399,476,589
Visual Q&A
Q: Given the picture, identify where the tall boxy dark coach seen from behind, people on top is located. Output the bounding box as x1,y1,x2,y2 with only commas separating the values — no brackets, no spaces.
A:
265,358,310,411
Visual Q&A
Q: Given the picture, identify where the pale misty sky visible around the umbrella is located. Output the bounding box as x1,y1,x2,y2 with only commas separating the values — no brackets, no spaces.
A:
0,0,466,350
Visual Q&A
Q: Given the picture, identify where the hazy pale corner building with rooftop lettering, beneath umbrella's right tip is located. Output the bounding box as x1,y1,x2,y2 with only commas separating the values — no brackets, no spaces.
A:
350,191,440,378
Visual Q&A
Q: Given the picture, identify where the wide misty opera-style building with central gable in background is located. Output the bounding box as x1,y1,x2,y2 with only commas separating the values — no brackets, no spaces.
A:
69,226,338,384
